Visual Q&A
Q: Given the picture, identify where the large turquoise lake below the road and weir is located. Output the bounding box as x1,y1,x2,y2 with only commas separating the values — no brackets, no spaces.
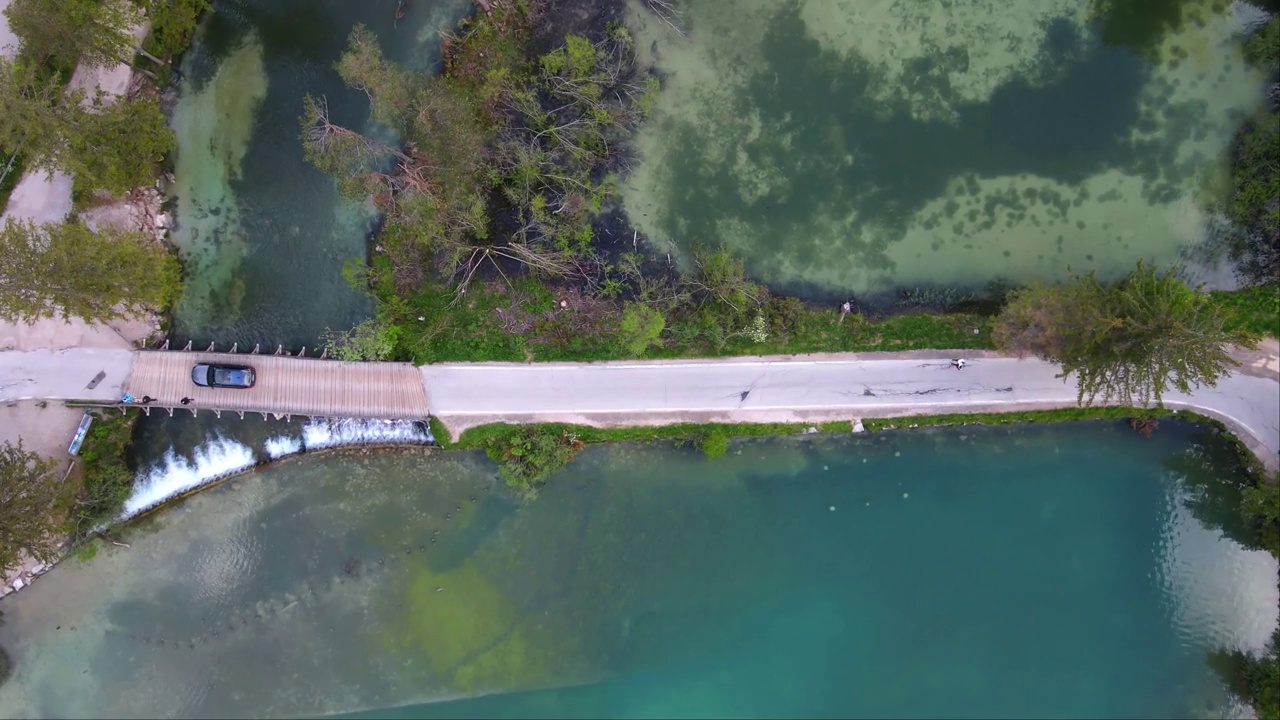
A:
0,423,1280,717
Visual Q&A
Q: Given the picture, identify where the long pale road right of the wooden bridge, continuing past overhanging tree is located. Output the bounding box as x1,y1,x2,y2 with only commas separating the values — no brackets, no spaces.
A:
422,352,1280,465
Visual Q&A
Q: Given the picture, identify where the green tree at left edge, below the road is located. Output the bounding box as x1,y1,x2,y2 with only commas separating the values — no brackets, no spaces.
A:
0,441,72,575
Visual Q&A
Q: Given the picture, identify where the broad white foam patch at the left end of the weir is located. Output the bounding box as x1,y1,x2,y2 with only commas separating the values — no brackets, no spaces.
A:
120,437,257,520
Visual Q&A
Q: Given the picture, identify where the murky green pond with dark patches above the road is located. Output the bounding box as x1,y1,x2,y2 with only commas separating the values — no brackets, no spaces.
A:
623,0,1265,296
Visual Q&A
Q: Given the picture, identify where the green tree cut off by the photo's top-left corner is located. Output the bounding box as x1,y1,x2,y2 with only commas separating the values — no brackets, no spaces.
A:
4,0,142,70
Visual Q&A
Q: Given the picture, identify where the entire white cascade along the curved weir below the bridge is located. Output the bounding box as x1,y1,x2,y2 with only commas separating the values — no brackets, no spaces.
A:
120,419,435,520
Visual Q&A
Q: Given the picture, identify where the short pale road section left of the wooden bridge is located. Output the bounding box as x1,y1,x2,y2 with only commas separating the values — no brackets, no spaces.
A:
0,348,134,402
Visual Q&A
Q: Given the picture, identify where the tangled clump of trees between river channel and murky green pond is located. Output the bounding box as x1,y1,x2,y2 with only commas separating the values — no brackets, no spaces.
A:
302,24,657,295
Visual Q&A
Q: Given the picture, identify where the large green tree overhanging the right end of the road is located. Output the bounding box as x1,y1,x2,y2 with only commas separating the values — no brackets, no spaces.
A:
995,263,1253,406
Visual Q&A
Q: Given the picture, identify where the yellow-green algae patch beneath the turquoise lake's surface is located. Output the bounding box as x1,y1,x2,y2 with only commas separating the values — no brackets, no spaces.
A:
384,550,548,693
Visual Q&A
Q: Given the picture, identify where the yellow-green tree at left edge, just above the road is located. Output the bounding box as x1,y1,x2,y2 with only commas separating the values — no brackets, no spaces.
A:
0,219,180,322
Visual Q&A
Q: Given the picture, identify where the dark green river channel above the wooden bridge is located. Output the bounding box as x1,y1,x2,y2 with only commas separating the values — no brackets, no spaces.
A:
163,0,466,351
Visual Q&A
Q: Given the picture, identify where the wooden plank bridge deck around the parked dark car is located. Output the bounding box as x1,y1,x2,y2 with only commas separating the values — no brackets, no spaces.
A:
124,351,428,420
